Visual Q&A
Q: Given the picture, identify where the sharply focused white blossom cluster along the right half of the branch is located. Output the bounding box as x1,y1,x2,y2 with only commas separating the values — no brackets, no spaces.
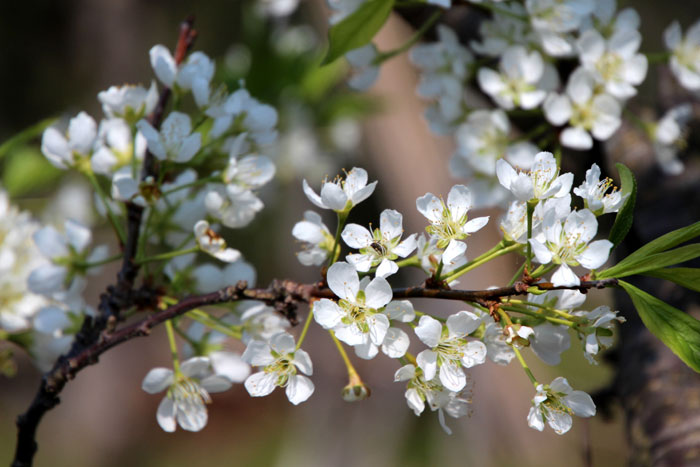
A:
284,160,626,433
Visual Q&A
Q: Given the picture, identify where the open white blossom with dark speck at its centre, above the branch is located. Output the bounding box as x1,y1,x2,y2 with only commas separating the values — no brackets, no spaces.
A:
341,209,416,277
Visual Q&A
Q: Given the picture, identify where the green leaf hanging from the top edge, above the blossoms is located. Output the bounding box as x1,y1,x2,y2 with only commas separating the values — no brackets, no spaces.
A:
322,0,394,65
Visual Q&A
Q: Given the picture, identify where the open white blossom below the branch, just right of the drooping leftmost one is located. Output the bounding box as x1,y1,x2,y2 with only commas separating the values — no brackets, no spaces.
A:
243,332,314,405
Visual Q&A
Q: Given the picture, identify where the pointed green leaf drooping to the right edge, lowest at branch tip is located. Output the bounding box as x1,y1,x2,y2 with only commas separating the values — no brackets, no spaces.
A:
619,281,700,373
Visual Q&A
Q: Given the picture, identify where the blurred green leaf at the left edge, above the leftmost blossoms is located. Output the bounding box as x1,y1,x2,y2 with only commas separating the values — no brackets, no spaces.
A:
2,146,63,197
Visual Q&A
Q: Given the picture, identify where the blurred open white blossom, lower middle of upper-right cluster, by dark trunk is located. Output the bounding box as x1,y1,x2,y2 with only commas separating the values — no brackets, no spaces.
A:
544,68,622,150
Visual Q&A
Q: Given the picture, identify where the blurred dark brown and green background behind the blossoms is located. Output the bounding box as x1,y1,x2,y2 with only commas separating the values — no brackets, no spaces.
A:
0,0,700,467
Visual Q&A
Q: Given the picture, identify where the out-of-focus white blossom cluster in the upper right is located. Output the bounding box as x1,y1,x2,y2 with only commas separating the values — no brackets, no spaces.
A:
400,0,700,207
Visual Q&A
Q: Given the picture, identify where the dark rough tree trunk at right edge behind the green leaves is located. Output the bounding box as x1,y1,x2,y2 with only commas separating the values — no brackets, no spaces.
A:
609,104,700,467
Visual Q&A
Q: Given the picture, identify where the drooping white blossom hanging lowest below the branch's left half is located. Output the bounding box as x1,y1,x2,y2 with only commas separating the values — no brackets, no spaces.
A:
141,357,231,432
